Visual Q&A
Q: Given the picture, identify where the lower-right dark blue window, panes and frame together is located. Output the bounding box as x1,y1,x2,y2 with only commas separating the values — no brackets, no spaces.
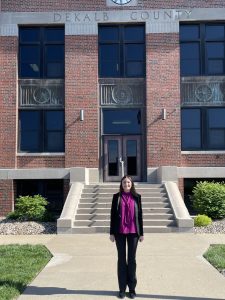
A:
181,107,225,150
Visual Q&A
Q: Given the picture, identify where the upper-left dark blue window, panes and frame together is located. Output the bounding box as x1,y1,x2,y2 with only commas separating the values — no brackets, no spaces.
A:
19,27,64,78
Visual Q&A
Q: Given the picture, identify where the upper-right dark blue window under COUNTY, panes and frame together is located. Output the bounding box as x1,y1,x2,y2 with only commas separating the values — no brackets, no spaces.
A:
180,23,225,76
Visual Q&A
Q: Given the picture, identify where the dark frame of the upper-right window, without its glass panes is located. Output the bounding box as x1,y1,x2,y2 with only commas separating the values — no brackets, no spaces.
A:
180,22,225,76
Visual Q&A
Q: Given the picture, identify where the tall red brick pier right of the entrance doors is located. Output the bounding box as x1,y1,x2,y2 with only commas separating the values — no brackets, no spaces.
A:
146,34,180,167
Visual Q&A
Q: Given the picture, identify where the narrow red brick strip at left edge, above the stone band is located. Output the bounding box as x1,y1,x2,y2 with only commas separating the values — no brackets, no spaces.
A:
0,37,17,168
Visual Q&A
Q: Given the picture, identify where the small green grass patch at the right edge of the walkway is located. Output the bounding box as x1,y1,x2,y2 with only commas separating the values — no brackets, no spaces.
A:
203,244,225,271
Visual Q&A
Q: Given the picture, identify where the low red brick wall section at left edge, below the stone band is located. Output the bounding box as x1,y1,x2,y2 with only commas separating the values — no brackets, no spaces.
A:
0,180,14,217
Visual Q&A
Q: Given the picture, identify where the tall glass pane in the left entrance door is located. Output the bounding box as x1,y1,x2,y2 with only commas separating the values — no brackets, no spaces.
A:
108,140,119,176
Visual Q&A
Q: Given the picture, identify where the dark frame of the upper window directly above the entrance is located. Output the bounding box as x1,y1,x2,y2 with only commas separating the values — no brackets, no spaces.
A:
98,23,146,78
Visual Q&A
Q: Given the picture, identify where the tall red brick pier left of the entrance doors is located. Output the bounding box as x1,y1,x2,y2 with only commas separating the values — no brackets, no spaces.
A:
65,36,99,167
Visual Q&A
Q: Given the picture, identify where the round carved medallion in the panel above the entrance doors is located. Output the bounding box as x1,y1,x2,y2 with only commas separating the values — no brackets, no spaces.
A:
112,85,133,104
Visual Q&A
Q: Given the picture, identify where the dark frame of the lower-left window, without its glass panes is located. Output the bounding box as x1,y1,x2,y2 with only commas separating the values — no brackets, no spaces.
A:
18,109,65,153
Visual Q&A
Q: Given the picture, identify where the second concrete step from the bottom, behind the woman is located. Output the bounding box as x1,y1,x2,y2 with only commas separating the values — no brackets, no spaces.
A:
73,220,176,227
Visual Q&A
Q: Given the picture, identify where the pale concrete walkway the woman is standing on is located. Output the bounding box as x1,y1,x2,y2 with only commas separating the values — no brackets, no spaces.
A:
0,233,225,300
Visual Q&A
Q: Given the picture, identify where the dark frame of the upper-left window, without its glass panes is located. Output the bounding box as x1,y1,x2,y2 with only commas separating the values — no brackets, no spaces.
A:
18,26,65,79
